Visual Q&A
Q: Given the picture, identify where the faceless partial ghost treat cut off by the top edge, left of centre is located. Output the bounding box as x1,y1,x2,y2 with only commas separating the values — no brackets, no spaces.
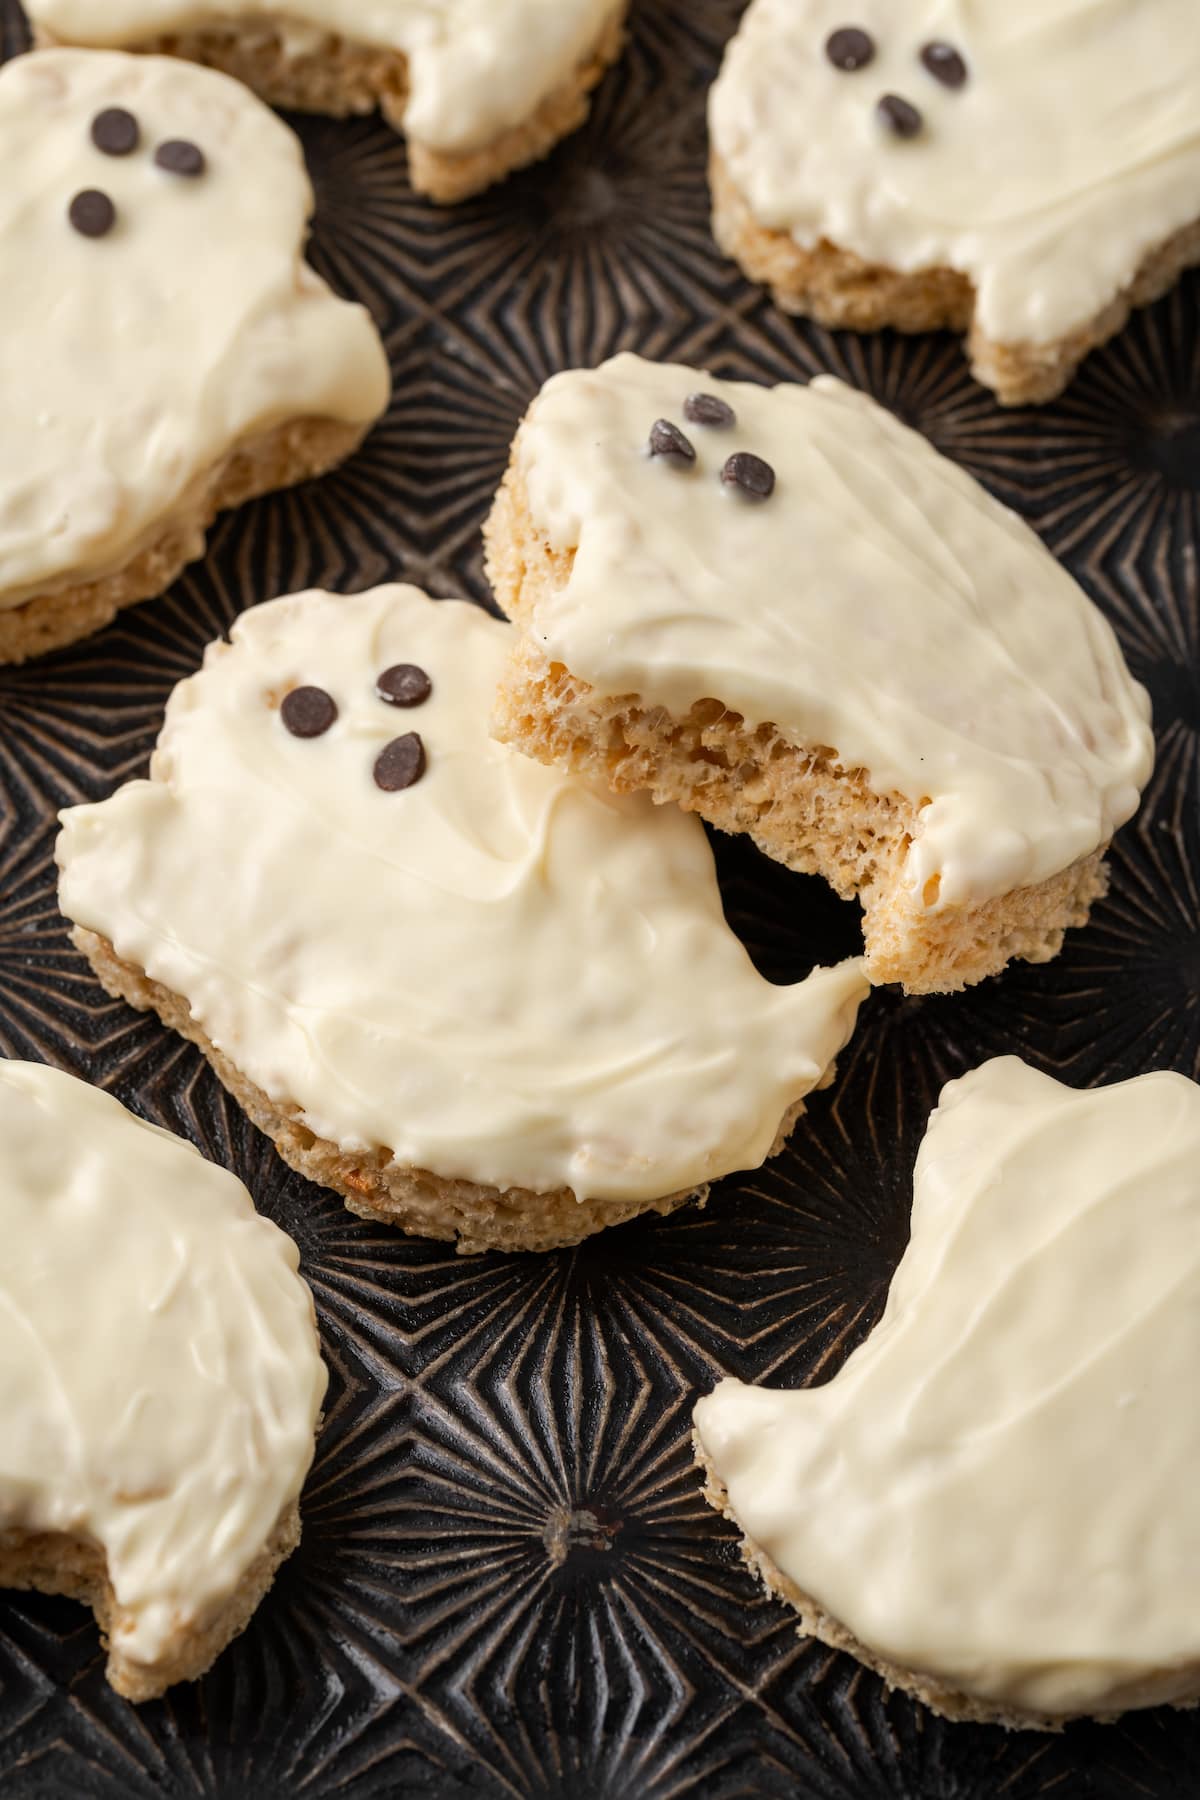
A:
25,0,628,202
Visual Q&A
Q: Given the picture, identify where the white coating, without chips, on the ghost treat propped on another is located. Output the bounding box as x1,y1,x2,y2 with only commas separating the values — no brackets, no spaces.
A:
515,356,1153,905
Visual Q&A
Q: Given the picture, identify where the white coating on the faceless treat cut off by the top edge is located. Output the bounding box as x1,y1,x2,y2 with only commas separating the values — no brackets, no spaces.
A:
27,0,615,153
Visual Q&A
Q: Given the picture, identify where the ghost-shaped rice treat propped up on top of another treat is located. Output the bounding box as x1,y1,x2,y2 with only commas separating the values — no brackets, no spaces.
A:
486,356,1153,994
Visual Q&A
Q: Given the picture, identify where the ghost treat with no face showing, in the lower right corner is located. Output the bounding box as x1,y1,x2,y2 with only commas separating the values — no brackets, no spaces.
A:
696,1057,1200,1726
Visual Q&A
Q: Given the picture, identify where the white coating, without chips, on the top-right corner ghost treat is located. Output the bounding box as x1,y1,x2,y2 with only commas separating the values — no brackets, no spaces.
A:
709,0,1200,344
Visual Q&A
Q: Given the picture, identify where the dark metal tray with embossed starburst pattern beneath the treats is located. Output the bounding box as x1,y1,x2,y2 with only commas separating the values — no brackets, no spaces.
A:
0,0,1200,1800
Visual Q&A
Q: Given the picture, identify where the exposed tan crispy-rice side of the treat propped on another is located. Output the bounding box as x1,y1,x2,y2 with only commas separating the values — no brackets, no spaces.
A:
486,464,1108,994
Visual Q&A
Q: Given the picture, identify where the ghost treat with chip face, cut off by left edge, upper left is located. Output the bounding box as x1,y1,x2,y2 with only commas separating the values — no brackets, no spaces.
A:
0,50,389,662
